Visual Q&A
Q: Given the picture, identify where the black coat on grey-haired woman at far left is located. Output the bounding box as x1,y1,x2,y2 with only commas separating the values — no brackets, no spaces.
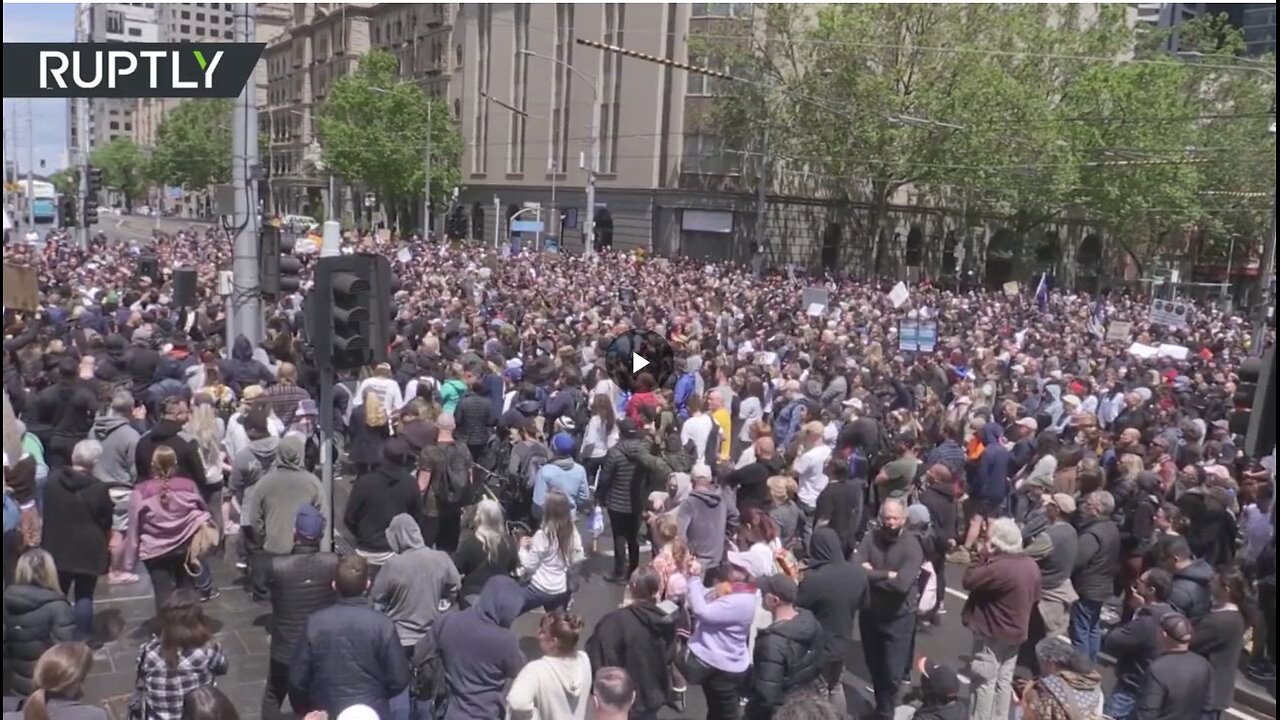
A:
41,466,114,577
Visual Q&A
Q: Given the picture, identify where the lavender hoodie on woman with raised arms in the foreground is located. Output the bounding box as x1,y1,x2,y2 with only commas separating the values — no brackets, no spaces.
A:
689,578,759,673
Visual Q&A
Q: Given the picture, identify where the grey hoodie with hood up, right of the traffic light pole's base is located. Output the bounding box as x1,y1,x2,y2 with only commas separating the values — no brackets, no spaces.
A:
369,512,462,647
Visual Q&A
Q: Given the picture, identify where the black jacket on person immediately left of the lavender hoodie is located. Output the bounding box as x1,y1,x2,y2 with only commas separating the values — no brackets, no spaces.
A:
586,602,676,712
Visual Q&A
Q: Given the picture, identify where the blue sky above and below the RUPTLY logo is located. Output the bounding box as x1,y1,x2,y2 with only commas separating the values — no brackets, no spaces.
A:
4,3,76,174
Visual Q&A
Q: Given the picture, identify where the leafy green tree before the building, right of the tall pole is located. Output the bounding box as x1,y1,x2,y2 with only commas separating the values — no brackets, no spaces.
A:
316,51,462,224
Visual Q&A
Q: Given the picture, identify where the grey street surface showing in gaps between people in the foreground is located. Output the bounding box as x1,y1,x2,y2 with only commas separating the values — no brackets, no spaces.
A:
72,471,1275,720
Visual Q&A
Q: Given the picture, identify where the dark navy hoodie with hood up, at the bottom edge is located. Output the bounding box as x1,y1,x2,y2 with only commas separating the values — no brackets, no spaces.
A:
428,575,525,720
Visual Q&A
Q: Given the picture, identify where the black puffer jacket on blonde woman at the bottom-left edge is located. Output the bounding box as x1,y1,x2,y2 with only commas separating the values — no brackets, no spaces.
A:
4,585,76,696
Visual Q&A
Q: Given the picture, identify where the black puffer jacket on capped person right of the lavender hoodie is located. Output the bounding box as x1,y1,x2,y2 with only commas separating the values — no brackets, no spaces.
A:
747,609,822,720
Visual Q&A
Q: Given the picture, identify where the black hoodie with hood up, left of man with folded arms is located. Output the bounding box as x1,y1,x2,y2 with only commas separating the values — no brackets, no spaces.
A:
796,528,870,661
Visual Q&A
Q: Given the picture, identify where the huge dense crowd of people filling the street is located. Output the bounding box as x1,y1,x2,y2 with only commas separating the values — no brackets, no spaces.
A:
3,224,1276,720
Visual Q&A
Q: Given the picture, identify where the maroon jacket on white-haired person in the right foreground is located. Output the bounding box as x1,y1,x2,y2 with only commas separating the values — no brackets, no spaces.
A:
960,555,1041,644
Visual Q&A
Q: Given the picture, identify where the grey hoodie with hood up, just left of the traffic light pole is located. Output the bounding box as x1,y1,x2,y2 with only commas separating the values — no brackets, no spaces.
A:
241,436,326,555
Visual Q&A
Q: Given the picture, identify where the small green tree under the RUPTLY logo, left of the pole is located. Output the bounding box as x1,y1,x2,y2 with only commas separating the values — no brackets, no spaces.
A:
150,99,232,190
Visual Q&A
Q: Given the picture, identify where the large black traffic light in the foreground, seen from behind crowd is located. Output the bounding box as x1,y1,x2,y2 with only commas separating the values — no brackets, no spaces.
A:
307,255,392,370
